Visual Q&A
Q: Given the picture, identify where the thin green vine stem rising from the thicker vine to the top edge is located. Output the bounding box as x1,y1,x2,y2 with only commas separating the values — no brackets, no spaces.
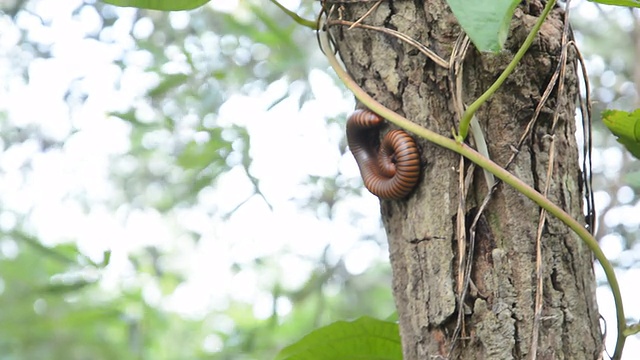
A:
456,0,556,142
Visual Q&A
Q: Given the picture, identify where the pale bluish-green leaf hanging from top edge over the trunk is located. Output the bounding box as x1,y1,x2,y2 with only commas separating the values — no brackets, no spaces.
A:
447,0,520,52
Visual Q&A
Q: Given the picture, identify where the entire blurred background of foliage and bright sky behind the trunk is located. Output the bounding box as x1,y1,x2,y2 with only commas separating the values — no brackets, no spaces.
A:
0,0,640,360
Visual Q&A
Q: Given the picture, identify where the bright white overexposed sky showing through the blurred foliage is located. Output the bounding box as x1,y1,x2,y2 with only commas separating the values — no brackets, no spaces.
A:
0,0,640,359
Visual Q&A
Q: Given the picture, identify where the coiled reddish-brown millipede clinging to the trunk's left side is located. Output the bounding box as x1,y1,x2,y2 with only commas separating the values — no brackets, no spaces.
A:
347,109,420,200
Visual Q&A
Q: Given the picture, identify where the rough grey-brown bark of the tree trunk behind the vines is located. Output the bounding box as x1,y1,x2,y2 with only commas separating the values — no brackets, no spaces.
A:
331,0,602,360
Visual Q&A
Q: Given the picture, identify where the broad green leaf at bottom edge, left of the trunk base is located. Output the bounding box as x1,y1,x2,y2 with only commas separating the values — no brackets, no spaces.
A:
276,316,402,360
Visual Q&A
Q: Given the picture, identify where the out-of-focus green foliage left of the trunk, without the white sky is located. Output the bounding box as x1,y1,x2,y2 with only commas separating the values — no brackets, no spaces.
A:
0,0,393,359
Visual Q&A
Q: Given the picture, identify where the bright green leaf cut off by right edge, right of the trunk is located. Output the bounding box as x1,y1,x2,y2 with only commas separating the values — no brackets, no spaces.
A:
602,109,640,159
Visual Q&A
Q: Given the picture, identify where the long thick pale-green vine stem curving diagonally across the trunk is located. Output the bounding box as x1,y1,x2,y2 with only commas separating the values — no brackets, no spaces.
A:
318,24,626,360
